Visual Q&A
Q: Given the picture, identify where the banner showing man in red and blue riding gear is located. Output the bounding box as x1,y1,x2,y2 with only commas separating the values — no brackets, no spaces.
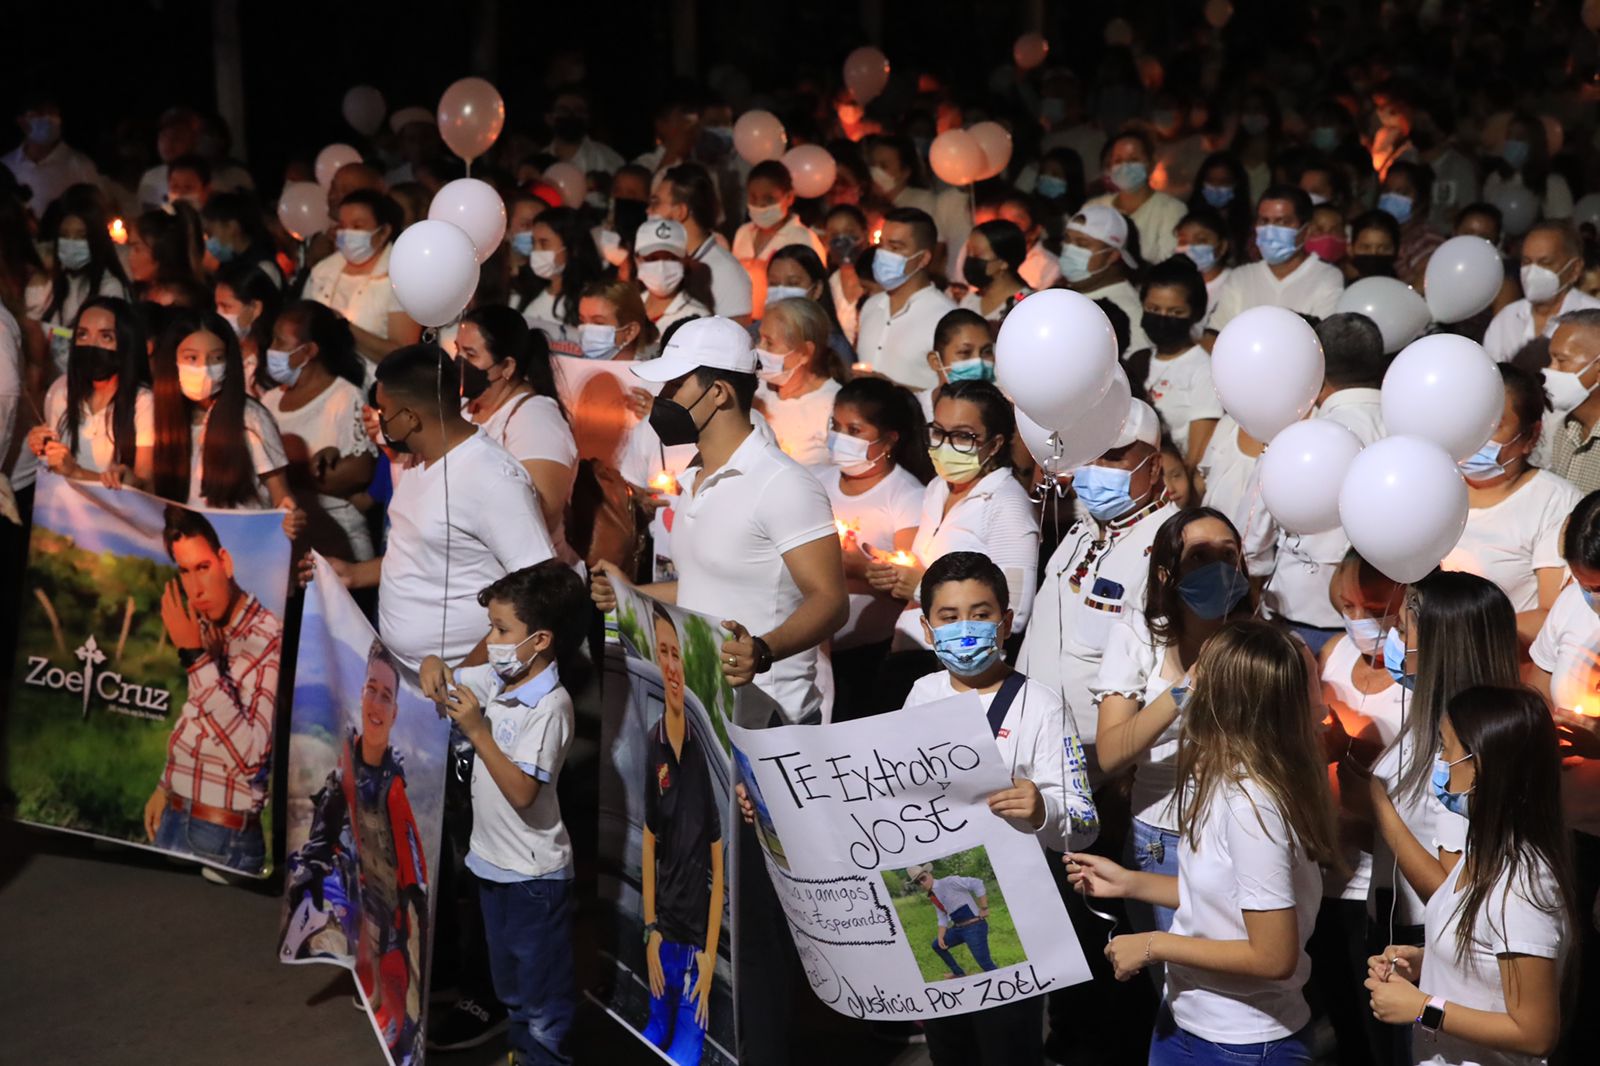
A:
278,555,450,1066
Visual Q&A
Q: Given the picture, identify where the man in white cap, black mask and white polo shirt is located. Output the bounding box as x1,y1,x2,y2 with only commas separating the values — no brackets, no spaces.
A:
590,317,850,1066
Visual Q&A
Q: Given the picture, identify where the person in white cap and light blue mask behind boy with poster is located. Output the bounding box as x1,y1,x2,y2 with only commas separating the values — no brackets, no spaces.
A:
1016,400,1178,765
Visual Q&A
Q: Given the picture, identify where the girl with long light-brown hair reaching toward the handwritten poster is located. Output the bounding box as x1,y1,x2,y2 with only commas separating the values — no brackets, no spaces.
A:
1066,621,1339,1066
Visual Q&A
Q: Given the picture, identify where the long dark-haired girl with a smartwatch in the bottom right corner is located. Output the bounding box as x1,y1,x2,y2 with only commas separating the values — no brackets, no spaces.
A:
1366,687,1574,1066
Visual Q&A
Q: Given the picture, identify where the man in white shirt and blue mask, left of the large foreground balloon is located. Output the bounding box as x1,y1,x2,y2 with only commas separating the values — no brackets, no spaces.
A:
856,208,955,389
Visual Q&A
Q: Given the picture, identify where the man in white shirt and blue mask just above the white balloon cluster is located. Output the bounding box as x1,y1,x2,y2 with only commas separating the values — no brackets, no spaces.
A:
1205,186,1344,333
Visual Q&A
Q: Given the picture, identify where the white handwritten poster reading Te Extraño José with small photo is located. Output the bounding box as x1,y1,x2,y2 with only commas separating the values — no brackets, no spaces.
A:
730,693,1090,1021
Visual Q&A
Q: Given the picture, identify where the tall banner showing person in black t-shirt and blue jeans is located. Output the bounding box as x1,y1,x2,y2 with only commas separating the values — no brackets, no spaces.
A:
595,581,738,1066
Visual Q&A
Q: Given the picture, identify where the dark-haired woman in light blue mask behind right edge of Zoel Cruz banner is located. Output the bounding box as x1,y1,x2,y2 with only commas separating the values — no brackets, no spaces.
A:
261,299,378,562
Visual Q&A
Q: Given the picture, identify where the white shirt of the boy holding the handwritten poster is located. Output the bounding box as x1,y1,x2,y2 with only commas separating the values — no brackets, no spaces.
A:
906,671,1099,852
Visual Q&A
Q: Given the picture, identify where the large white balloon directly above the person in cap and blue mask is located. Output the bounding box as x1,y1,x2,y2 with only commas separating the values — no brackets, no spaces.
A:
995,288,1117,429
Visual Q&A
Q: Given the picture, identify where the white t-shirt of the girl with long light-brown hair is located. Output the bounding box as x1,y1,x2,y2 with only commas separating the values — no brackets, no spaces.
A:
1166,781,1322,1044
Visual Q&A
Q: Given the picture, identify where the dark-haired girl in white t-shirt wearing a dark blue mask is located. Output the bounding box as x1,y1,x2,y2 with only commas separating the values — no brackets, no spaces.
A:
1090,507,1251,932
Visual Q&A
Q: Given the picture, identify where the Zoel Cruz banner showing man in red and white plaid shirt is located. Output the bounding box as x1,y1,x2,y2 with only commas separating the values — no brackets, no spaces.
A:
8,471,290,877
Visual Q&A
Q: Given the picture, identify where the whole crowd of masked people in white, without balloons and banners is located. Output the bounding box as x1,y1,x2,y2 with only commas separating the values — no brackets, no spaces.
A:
9,3,1600,1064
